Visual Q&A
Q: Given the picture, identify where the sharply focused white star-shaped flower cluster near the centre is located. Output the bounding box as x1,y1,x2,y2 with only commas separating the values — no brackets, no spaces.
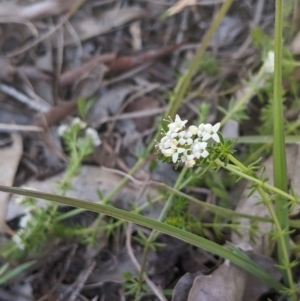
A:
156,115,220,167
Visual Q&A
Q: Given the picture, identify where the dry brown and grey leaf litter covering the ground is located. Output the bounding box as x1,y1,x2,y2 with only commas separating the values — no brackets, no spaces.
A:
0,0,299,301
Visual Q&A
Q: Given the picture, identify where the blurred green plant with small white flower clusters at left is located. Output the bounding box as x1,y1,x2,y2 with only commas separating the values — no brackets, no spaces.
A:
1,118,101,259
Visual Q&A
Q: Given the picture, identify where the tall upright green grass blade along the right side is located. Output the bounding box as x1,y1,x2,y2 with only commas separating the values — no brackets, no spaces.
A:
273,0,292,288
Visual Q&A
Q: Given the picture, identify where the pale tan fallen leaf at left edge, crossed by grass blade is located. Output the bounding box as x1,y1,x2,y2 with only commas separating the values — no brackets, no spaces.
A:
0,133,23,233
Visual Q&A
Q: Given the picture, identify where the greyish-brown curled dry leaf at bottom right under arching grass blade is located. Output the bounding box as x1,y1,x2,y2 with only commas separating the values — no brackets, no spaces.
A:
172,251,281,301
